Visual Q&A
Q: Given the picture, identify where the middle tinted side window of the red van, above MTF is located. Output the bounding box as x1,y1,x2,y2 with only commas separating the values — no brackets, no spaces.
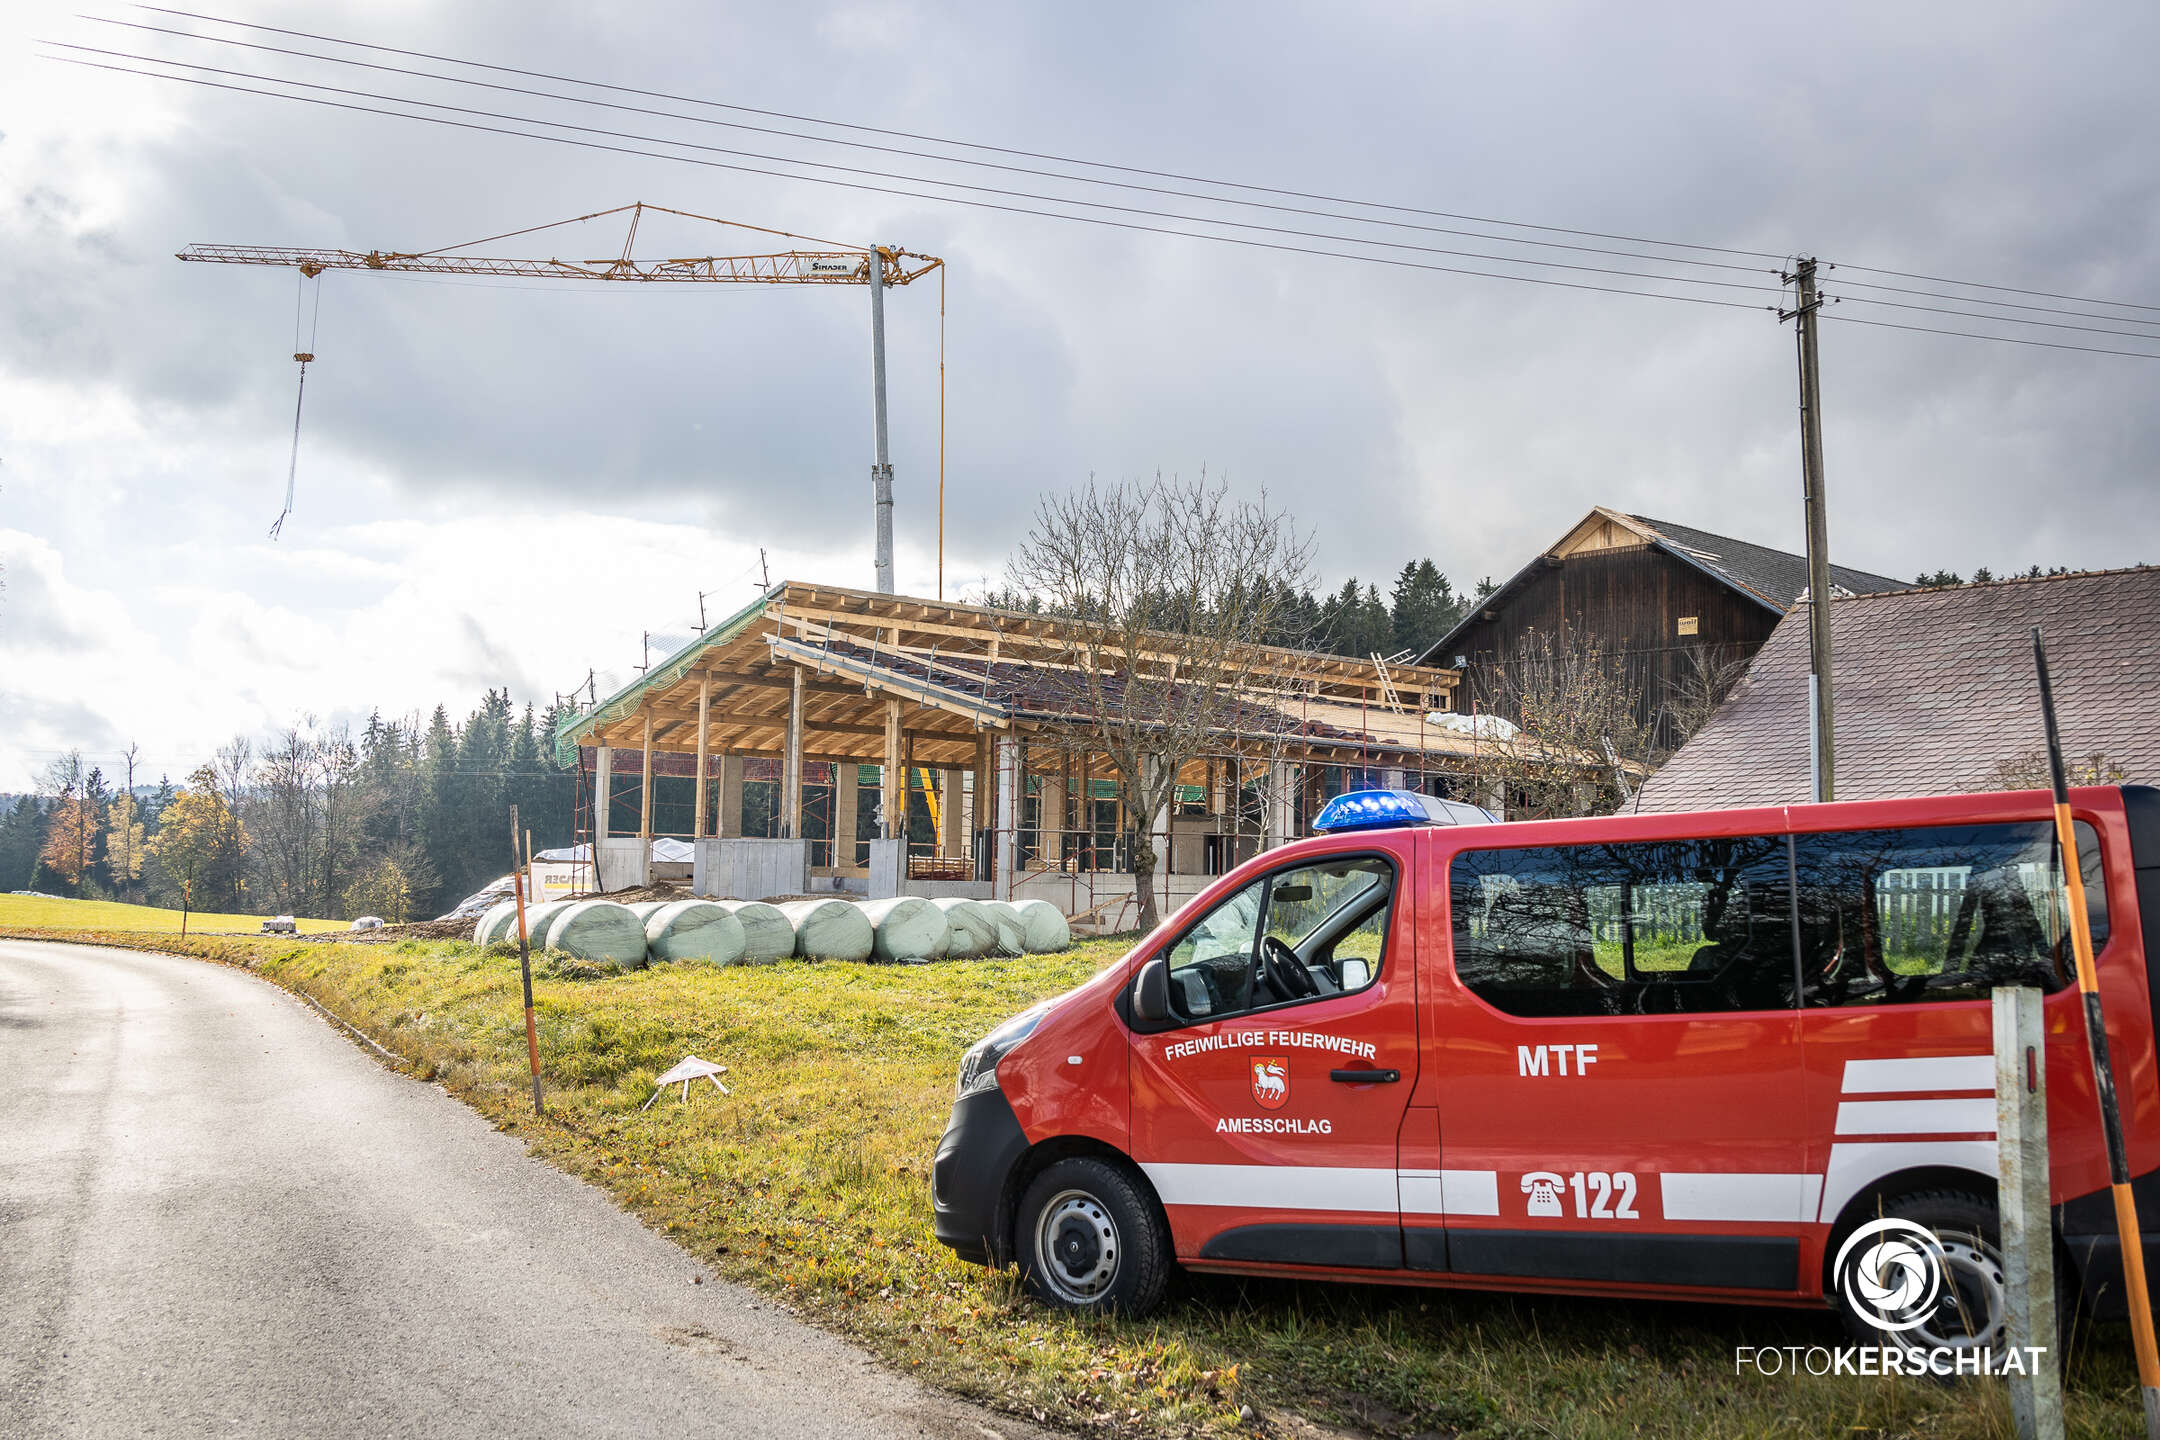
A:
1449,836,1793,1015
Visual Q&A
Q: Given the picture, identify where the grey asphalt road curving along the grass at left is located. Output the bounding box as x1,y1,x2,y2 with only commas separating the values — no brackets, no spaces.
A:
0,941,1037,1440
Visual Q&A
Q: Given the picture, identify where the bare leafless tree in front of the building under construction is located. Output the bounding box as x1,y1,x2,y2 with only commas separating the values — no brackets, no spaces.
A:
1009,473,1311,928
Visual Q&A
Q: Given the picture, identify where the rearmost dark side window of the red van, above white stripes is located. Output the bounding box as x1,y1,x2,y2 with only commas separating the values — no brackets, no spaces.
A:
1793,820,2108,1006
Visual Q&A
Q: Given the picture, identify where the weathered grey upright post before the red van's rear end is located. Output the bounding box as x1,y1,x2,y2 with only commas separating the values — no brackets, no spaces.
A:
1996,984,2063,1440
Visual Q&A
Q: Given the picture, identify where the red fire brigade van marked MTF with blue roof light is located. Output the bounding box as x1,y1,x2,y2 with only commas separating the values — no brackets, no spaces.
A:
933,786,2160,1347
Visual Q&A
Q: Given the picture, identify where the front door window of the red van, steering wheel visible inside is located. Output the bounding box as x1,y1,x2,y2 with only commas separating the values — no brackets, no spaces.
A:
1166,855,1395,1023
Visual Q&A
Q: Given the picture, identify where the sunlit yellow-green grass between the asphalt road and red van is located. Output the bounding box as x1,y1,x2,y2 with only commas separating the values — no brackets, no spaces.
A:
4,935,2138,1438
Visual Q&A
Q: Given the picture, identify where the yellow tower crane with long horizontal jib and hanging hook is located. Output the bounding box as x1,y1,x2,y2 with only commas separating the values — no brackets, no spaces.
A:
179,201,946,600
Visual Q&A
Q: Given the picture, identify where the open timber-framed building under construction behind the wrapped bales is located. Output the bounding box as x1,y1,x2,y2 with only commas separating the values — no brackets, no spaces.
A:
555,581,1529,928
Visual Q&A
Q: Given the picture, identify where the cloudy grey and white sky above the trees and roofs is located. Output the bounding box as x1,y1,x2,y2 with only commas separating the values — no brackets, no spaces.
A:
0,0,2160,790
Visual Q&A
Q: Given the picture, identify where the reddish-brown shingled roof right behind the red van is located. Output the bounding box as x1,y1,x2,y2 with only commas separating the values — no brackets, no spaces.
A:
1639,568,2160,812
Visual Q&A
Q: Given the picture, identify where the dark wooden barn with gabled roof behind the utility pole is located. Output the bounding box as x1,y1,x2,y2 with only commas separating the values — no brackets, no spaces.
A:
1419,505,1907,747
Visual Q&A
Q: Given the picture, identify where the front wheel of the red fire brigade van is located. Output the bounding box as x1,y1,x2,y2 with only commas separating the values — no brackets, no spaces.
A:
1013,1157,1171,1317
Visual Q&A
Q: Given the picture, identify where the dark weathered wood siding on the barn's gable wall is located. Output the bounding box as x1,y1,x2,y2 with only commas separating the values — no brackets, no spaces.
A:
1432,546,1778,743
